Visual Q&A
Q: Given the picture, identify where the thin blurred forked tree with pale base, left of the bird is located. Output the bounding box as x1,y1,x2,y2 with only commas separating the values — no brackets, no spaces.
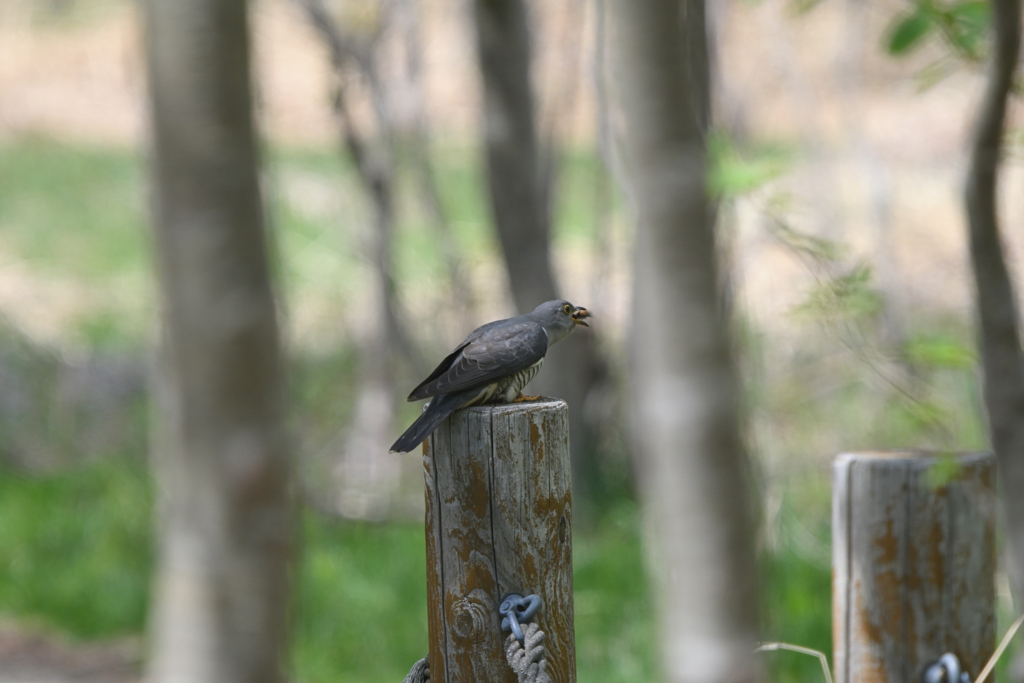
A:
296,0,417,519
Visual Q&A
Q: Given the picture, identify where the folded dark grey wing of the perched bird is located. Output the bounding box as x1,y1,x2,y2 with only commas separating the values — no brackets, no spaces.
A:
409,321,548,400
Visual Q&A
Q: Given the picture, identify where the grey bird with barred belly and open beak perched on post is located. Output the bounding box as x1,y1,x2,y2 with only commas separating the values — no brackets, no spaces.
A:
391,300,590,453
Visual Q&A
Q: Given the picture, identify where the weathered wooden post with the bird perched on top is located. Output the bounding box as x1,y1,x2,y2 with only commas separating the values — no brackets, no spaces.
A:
423,398,575,683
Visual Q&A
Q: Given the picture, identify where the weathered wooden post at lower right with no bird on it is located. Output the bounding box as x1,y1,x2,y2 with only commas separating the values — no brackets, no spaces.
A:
833,451,995,683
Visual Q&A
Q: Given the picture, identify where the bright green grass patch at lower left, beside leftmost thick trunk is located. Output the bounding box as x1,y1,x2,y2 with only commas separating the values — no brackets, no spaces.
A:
0,459,153,638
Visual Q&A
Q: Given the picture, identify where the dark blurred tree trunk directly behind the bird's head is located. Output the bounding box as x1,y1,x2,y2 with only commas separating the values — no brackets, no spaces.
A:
473,0,606,521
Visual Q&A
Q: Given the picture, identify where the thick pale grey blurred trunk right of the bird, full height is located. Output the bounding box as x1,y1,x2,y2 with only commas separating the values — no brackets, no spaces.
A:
609,0,760,683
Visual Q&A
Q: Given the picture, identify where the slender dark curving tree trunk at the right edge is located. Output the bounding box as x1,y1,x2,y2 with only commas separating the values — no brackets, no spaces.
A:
966,0,1024,681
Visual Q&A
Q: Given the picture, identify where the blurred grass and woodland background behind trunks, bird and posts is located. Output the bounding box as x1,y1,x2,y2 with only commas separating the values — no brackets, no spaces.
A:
0,0,1024,683
